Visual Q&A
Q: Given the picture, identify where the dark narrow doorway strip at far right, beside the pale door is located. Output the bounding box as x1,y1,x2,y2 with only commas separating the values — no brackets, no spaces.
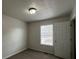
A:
71,19,76,59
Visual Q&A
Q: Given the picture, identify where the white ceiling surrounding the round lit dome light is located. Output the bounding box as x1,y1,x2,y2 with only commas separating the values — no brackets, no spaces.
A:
3,0,75,21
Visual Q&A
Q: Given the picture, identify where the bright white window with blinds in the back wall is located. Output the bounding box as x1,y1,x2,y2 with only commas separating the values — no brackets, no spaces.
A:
40,25,53,46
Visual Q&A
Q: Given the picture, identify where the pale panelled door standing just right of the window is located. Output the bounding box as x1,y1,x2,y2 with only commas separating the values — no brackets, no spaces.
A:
54,22,71,59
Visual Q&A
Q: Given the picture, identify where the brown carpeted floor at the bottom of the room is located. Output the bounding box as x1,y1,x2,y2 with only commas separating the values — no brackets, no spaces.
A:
7,50,60,59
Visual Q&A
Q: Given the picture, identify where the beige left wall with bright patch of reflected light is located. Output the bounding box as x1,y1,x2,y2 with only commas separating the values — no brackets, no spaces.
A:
2,15,27,59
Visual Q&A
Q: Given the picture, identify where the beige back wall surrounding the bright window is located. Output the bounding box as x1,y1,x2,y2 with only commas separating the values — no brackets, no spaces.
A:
28,17,69,54
